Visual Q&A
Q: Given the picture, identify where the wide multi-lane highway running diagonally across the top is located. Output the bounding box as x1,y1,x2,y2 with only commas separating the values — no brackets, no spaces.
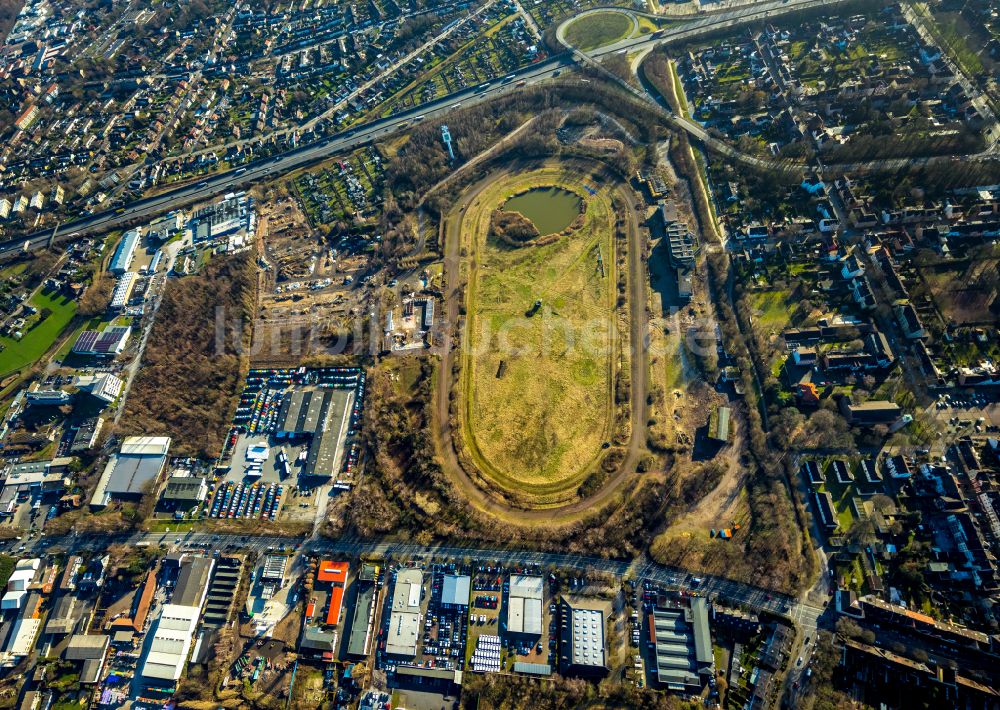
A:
0,0,843,256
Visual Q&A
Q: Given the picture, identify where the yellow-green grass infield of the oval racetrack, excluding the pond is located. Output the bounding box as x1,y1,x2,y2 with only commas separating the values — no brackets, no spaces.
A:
462,167,620,502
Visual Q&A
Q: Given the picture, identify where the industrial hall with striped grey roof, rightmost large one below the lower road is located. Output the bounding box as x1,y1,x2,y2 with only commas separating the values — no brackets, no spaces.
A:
649,597,715,693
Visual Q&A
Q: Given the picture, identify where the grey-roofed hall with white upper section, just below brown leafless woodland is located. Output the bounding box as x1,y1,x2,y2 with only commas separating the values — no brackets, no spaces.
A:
90,436,170,507
